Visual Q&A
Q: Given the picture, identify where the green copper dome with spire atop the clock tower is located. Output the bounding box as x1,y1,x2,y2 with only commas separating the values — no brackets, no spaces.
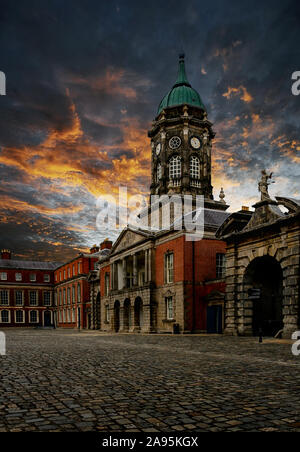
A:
157,55,205,115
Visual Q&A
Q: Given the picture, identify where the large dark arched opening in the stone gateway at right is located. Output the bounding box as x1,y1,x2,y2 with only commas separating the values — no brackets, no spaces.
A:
244,256,283,336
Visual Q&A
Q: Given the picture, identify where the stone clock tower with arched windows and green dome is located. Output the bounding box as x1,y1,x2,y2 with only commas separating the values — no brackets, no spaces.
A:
148,55,221,208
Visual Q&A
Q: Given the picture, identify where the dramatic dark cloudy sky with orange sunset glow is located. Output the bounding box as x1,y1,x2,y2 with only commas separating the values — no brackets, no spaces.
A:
0,0,300,261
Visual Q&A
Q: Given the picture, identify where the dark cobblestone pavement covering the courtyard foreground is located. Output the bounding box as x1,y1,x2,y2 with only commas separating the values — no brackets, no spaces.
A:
0,329,300,433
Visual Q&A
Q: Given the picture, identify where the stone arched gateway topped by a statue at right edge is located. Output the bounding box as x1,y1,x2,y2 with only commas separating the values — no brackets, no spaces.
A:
217,188,300,338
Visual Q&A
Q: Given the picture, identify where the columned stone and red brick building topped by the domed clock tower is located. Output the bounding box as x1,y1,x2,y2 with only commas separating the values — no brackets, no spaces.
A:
99,55,229,333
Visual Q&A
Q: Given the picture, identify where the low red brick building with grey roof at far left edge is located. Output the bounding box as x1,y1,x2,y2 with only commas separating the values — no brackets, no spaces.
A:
0,250,59,327
